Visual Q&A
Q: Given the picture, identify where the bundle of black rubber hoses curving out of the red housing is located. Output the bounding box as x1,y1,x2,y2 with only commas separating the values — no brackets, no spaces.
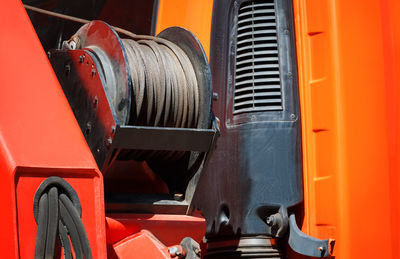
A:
33,176,92,259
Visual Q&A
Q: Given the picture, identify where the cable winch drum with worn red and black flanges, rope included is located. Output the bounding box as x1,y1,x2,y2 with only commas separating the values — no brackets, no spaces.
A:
75,21,212,171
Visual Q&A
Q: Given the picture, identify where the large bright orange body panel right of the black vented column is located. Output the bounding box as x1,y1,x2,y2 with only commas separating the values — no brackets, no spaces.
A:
293,0,400,259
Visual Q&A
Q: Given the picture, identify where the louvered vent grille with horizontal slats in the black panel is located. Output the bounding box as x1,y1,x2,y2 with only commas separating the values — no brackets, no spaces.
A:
233,0,283,114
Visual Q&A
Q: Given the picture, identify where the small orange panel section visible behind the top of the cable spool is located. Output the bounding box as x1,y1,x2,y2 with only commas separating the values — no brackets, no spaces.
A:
156,0,213,56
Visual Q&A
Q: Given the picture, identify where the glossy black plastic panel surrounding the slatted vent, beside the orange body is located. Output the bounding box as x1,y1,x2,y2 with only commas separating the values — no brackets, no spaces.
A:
193,0,303,238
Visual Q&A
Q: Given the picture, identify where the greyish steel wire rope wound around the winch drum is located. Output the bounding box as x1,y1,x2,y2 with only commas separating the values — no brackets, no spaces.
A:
122,39,199,128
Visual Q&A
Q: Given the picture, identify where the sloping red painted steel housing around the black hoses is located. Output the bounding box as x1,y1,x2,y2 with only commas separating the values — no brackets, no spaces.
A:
0,1,106,258
